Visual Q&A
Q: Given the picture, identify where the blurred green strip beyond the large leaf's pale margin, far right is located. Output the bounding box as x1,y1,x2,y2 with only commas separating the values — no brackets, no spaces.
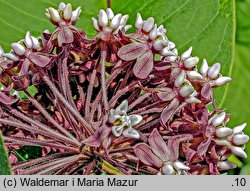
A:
224,0,250,162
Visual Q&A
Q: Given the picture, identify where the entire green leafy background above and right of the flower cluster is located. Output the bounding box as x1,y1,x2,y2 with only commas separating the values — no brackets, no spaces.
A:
0,0,250,174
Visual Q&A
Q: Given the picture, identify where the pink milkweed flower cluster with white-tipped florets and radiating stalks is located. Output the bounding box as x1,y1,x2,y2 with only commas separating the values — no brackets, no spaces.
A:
0,3,249,175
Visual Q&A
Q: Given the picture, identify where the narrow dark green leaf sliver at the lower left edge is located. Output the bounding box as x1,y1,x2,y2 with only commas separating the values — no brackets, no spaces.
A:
0,131,11,175
